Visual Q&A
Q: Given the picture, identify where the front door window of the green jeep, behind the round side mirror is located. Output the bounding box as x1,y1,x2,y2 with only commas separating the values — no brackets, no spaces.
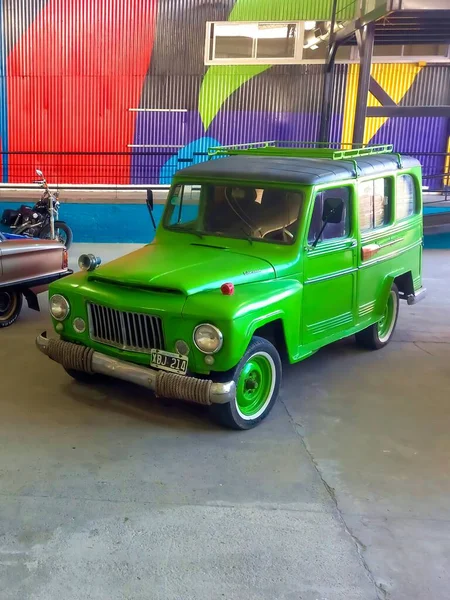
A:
308,187,350,243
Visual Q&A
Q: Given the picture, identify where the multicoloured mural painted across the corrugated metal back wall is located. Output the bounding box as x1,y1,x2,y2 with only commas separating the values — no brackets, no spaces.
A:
0,0,450,184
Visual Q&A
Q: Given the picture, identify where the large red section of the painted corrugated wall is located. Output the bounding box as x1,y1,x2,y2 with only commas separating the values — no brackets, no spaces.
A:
7,0,157,183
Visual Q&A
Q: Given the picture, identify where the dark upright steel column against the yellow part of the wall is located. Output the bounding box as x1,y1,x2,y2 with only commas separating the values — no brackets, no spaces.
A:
353,22,375,145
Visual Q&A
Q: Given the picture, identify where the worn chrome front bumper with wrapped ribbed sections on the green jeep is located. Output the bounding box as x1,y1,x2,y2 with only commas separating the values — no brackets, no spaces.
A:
36,331,236,405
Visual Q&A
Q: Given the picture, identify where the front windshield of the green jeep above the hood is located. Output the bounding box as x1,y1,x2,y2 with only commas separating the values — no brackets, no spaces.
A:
164,184,303,244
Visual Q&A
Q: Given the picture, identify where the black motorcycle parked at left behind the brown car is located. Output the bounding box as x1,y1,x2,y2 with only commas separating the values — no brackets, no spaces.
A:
1,169,73,248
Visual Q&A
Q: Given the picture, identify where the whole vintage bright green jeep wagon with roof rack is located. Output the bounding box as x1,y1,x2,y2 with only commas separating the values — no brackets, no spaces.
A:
37,143,425,429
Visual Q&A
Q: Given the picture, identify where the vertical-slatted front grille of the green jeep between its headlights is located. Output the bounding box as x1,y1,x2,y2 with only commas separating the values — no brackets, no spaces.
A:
88,304,164,352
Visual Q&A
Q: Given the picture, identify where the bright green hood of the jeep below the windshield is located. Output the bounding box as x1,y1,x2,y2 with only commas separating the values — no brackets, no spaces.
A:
89,243,275,296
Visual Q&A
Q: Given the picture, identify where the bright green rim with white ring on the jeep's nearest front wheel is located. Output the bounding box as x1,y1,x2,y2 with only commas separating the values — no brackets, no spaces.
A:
236,352,275,419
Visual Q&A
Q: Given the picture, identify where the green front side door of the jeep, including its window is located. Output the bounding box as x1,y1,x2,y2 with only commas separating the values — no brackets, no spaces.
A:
302,186,357,349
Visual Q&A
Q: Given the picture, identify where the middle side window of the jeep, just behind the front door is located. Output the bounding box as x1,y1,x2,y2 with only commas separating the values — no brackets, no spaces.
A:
358,177,392,231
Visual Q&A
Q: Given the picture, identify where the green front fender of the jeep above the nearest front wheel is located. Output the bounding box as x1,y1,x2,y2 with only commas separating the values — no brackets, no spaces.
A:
183,279,302,372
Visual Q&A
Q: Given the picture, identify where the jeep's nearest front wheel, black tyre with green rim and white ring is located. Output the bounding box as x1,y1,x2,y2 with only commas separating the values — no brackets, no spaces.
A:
211,336,282,429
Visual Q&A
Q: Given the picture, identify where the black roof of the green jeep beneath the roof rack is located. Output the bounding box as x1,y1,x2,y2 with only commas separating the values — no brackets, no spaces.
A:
176,154,420,185
